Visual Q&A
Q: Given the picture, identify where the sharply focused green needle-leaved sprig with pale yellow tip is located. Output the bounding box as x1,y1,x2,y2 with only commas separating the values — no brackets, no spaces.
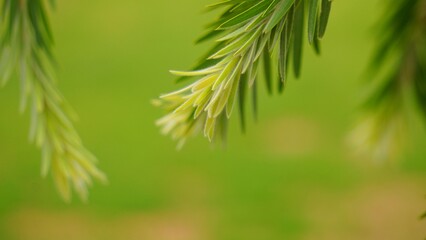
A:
156,0,331,145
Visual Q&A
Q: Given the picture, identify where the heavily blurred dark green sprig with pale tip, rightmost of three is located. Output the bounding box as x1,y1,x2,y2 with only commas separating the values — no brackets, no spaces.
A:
353,0,426,159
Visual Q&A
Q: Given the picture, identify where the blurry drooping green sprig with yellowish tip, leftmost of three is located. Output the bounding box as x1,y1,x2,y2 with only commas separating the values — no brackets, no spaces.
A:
0,0,106,201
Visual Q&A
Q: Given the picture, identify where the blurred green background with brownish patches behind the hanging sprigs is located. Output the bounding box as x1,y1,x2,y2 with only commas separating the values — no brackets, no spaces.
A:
0,0,426,240
